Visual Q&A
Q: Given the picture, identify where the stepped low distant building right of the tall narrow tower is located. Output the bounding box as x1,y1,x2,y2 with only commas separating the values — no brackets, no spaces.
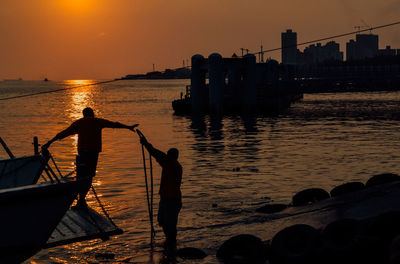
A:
302,41,343,64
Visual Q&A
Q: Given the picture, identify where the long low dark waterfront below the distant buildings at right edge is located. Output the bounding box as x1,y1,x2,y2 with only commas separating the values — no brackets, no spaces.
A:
287,56,400,93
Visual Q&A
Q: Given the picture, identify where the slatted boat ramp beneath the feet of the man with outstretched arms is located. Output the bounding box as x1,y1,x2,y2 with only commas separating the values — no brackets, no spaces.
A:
44,207,123,248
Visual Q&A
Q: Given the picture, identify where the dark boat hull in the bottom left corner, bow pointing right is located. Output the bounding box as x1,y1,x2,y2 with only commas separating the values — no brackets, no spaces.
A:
0,178,88,263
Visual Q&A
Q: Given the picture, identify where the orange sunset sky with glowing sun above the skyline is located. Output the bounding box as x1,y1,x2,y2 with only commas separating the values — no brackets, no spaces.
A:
0,0,400,80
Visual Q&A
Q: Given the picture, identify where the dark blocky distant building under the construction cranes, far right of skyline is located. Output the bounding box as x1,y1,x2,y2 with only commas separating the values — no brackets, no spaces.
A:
346,34,379,61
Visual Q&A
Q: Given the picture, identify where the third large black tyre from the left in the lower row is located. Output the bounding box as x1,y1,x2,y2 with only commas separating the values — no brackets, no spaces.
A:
321,219,360,258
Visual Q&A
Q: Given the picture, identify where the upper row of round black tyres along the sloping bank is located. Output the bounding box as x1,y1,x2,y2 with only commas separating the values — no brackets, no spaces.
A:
256,173,400,214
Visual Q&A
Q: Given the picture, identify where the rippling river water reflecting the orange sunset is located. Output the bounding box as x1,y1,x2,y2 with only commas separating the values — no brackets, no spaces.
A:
0,80,400,263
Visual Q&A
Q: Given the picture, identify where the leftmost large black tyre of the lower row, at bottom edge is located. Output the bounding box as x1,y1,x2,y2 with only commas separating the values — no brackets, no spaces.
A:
217,234,268,264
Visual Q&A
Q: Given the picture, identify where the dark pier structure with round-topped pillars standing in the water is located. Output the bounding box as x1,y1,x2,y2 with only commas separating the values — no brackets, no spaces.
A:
172,53,302,114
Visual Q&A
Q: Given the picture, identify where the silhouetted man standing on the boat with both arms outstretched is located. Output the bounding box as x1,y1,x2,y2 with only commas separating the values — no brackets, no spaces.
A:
42,107,138,207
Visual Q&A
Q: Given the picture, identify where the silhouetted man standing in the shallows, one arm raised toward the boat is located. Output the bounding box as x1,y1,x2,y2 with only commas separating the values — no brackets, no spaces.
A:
140,135,182,246
